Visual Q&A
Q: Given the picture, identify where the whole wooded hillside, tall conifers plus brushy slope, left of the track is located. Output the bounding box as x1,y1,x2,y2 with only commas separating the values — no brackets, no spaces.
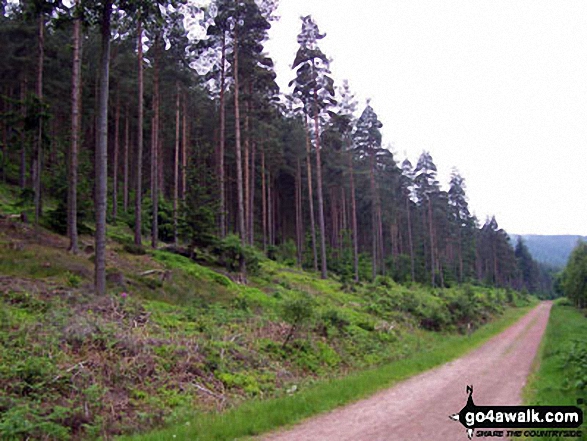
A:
0,0,560,439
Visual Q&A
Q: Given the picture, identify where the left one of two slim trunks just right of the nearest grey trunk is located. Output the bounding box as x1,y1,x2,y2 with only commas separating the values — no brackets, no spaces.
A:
135,16,144,246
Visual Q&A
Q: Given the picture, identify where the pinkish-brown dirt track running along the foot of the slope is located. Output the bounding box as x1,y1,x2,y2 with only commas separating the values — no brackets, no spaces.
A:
263,302,552,441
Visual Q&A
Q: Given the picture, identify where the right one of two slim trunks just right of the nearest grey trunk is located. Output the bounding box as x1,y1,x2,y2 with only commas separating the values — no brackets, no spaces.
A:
151,34,160,248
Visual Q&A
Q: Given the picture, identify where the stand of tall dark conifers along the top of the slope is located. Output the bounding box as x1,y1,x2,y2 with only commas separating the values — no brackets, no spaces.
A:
0,0,553,293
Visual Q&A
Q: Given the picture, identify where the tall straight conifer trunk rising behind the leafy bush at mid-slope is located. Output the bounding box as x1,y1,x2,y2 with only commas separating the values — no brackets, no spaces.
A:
233,27,247,281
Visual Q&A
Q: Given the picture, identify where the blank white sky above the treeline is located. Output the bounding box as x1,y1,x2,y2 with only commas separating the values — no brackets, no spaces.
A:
266,0,587,235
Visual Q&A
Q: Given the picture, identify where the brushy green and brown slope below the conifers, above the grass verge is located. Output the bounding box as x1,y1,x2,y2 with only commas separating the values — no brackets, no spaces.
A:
0,219,532,440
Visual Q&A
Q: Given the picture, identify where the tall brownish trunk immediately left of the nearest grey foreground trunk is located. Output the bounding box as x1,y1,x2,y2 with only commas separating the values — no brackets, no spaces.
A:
67,5,82,254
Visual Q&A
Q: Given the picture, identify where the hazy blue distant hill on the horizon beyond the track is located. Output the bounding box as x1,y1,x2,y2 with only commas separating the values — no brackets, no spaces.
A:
510,234,587,268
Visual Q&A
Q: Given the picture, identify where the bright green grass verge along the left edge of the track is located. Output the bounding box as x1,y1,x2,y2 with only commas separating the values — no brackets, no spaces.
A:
119,306,530,441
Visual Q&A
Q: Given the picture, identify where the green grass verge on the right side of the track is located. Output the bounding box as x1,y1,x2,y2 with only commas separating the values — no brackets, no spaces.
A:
522,299,587,441
